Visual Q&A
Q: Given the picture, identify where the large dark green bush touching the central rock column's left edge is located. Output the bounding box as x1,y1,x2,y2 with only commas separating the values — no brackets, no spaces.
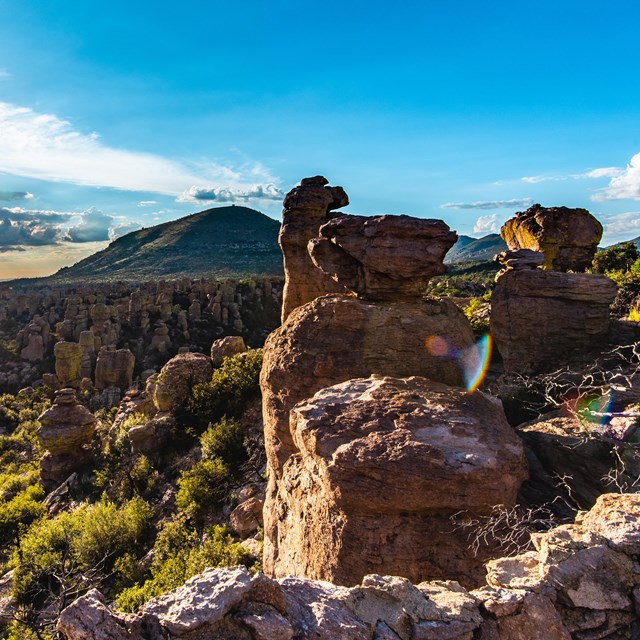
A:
186,349,262,430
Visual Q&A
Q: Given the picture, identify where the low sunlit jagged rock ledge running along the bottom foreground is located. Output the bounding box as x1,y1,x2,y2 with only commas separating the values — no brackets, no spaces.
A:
58,494,640,640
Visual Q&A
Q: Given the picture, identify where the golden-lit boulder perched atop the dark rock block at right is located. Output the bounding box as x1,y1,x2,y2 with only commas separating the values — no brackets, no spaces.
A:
500,204,602,271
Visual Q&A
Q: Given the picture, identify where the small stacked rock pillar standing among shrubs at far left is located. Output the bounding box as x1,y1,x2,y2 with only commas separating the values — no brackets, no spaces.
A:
38,389,96,488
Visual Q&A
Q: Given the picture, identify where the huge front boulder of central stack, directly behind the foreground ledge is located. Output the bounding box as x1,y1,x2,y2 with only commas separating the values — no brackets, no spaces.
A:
264,376,527,585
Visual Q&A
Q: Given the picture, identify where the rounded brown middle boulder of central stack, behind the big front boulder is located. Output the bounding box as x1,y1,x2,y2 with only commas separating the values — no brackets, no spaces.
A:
260,295,473,475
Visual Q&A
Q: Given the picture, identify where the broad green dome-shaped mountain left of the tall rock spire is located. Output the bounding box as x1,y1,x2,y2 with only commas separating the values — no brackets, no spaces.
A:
39,205,283,284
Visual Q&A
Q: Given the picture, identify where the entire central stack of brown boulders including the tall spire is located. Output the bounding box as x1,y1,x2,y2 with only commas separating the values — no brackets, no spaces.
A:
261,178,526,584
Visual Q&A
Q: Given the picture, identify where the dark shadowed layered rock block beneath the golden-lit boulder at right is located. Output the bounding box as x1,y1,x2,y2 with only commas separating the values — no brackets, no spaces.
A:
491,269,617,374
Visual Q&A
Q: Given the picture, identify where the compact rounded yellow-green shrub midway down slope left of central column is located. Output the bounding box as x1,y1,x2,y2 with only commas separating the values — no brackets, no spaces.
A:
176,458,231,522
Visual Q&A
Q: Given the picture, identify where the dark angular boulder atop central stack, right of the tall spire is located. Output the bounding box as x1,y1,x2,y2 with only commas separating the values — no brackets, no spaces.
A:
309,215,458,300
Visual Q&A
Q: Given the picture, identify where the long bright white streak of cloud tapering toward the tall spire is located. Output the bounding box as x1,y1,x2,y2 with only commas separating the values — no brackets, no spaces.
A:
0,102,277,197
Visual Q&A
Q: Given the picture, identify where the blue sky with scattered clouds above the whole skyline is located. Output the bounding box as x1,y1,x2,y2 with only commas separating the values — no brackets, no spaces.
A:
0,0,640,277
